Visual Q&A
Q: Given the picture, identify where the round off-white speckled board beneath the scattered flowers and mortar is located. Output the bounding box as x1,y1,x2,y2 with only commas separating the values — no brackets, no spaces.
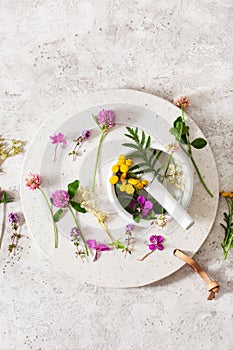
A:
21,90,219,288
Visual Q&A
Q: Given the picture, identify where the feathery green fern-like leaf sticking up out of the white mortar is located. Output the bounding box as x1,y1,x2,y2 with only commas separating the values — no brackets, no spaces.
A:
122,126,164,182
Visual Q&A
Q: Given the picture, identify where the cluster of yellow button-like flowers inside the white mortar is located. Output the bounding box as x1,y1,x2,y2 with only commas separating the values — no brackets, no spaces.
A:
109,155,148,194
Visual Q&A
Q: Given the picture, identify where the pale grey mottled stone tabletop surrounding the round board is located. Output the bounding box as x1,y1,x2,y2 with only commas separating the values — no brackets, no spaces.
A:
0,0,233,350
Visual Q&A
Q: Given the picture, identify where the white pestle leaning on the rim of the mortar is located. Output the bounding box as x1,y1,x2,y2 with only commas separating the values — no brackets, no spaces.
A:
146,178,194,230
